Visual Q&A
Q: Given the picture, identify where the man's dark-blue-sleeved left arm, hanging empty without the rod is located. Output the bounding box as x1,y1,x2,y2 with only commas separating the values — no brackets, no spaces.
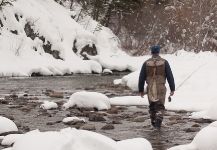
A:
138,63,146,94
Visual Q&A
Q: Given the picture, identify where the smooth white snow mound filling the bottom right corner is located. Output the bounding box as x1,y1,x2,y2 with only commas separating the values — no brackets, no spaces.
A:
168,121,217,150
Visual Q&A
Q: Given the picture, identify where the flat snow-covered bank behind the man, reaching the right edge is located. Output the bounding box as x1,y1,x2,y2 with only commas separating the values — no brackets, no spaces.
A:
114,51,217,119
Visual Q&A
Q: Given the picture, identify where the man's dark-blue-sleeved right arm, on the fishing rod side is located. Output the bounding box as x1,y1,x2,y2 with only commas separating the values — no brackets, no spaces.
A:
165,61,175,96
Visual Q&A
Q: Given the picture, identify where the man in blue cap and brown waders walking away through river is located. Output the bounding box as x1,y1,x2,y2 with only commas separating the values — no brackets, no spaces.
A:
139,45,175,128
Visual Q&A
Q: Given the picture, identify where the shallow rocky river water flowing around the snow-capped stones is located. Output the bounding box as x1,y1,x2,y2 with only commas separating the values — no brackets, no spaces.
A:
0,73,211,150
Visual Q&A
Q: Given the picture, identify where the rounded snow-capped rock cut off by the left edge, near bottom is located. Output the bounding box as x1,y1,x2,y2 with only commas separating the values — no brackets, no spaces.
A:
0,116,18,134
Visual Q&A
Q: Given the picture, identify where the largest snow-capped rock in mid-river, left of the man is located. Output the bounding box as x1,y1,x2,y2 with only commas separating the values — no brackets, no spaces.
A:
63,91,111,110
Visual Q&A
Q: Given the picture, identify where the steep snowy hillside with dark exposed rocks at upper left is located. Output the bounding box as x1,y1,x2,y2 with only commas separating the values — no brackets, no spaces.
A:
0,0,131,76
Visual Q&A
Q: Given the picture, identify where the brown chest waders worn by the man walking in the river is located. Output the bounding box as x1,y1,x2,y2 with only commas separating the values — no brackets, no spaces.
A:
146,57,166,128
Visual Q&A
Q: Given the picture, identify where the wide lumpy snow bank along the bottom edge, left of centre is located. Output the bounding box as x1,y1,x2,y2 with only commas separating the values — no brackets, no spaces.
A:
8,128,152,150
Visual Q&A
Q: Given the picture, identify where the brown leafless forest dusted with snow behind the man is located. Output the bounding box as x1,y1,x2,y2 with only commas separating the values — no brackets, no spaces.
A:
56,0,217,55
